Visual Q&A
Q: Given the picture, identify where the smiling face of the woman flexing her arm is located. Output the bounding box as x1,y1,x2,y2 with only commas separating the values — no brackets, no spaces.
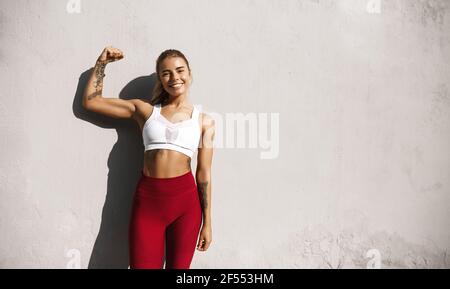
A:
159,57,191,96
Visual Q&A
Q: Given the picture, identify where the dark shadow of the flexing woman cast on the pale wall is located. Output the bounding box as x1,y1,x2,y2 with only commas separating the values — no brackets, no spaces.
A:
73,68,156,269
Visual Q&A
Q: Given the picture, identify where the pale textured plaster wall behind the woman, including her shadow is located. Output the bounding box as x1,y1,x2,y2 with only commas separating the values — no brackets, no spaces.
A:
0,0,450,268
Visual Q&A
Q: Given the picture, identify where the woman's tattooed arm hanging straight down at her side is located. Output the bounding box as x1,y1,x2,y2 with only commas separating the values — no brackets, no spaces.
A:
195,114,215,251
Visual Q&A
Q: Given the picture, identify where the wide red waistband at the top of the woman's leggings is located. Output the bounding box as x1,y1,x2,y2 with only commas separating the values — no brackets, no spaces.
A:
137,170,197,196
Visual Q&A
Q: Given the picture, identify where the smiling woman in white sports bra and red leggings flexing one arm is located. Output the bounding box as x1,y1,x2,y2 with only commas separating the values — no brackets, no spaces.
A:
83,46,215,269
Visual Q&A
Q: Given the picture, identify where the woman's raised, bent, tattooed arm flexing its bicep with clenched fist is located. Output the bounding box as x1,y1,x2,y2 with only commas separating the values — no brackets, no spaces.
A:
83,47,136,118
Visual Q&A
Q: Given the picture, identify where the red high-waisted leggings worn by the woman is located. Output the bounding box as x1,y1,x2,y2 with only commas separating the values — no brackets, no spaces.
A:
129,171,202,269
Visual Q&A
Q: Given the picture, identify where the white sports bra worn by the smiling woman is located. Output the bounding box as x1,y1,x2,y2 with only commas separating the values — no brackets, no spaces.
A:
142,104,201,158
